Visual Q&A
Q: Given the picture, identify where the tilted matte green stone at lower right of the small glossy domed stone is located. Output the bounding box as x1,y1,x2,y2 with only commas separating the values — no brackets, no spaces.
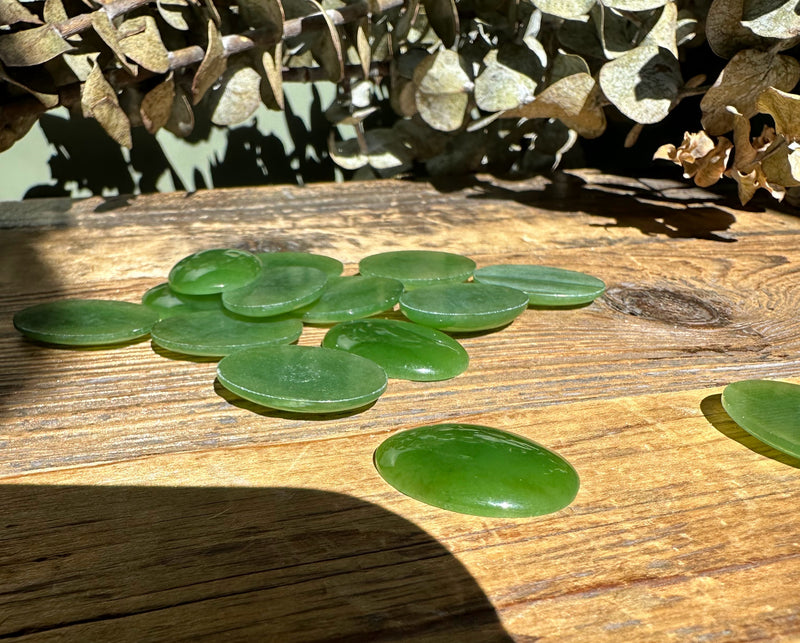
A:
222,266,328,317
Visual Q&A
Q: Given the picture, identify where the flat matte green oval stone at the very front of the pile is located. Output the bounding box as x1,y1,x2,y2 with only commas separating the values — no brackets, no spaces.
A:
217,346,386,413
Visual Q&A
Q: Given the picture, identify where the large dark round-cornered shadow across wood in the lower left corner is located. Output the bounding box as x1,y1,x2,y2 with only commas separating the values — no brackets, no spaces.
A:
0,485,511,643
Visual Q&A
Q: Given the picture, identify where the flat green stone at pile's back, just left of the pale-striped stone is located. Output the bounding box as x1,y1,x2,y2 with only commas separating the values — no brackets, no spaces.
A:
358,250,475,290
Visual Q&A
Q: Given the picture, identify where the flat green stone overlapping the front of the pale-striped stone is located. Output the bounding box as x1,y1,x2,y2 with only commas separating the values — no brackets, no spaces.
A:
400,283,528,332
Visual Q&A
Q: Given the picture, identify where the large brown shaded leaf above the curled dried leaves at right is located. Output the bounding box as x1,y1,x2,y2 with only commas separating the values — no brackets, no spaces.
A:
700,49,800,136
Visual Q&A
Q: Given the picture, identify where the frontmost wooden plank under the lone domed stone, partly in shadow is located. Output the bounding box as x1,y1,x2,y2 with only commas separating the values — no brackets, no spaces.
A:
0,389,800,641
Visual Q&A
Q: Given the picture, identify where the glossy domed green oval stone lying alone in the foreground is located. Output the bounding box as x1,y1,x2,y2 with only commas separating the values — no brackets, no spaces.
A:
375,424,580,518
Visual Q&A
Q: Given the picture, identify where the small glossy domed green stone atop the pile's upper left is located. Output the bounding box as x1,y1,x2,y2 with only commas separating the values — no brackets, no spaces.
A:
169,248,261,295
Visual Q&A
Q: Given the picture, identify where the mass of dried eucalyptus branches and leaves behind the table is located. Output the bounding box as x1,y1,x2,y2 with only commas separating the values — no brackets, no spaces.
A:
0,0,800,201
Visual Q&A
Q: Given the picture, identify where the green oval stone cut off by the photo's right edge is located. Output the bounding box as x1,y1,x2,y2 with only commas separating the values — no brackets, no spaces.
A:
722,380,800,458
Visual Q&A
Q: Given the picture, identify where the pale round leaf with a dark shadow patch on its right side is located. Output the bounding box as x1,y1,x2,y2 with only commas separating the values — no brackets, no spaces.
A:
598,45,683,124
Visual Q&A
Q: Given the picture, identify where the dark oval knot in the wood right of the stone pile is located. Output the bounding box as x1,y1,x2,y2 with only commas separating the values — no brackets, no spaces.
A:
604,286,730,327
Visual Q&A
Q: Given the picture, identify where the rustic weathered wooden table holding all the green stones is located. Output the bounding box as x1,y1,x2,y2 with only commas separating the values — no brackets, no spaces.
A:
0,172,800,642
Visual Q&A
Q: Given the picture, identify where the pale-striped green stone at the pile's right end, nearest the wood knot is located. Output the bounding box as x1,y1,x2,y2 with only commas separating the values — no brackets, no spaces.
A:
474,264,606,306
